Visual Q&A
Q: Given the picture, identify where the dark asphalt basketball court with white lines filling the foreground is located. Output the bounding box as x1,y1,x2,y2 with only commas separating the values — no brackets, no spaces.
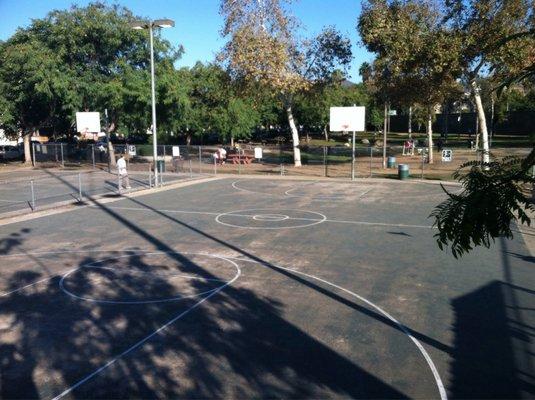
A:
0,178,535,398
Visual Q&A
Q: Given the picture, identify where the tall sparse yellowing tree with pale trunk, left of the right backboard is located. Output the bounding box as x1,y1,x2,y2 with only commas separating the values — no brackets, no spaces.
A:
221,0,351,166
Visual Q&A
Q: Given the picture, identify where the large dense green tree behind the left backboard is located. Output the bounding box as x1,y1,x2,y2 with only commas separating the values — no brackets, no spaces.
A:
0,2,181,162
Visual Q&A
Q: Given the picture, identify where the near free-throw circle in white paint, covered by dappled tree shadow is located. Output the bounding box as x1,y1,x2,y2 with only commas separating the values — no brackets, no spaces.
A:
59,252,239,305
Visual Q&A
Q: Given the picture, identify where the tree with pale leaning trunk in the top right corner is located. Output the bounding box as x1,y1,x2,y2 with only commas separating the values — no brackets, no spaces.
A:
443,0,535,163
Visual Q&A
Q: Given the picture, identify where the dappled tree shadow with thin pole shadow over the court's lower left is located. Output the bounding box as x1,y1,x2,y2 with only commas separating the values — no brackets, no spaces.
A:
0,171,407,398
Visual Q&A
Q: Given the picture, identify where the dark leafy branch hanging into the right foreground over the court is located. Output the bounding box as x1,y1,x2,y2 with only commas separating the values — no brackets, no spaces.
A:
431,149,535,258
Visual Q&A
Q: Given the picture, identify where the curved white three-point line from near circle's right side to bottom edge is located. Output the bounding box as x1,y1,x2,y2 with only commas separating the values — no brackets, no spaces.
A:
226,257,448,400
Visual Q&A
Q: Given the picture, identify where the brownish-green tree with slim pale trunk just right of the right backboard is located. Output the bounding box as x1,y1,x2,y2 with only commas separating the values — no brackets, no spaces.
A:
358,0,460,163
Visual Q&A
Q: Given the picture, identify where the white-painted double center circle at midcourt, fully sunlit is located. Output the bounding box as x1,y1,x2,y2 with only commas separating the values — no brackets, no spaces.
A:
215,209,327,229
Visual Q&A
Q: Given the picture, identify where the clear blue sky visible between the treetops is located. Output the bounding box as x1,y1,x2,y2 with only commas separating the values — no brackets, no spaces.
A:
0,0,373,82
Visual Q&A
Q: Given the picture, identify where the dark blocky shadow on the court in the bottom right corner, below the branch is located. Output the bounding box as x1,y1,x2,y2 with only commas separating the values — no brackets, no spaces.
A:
450,239,535,399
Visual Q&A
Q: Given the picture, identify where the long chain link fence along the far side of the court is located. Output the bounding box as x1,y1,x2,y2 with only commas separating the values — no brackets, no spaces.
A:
29,143,529,179
